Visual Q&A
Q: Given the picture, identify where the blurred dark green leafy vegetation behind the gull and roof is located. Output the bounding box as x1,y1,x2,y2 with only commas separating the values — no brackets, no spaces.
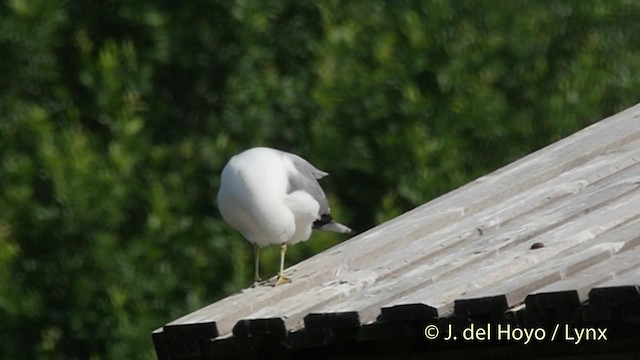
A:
0,0,640,359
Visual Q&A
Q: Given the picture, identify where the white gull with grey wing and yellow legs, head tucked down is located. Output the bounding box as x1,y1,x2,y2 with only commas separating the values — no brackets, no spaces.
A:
218,147,353,286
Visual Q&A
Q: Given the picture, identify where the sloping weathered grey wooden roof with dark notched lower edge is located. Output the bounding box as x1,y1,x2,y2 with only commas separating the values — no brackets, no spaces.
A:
153,105,640,359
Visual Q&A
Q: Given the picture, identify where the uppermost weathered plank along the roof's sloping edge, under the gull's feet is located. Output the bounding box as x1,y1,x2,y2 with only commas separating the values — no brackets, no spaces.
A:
165,102,640,336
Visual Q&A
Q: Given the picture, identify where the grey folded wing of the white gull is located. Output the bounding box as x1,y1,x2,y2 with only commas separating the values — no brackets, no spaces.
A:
283,152,329,215
